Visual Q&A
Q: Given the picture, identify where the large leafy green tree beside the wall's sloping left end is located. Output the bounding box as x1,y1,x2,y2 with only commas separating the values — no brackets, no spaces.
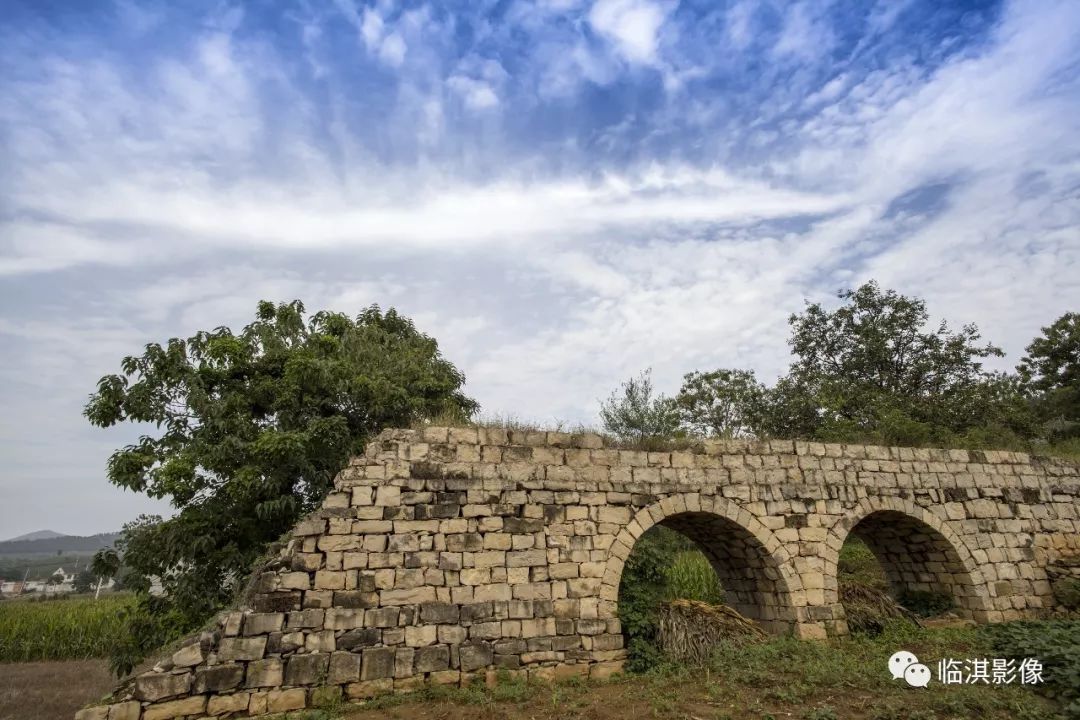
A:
85,301,477,673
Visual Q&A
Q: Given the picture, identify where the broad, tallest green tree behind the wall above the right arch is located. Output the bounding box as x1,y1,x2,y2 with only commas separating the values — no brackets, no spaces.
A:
765,282,1026,445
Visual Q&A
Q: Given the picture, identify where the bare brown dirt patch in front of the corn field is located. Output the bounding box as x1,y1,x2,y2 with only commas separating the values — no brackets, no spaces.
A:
0,660,113,720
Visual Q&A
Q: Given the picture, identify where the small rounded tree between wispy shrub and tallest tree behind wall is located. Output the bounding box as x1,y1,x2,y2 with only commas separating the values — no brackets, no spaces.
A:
675,369,766,438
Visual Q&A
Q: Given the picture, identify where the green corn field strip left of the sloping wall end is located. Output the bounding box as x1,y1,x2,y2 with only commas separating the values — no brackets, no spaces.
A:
0,596,131,663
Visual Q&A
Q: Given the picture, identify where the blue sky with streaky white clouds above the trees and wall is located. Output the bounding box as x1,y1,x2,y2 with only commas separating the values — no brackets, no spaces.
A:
0,0,1080,538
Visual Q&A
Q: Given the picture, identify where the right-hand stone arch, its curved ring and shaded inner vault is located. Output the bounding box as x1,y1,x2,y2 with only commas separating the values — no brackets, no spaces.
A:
826,507,987,619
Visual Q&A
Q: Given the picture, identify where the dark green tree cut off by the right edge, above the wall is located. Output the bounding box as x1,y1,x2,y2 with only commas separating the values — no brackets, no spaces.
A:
1016,312,1080,439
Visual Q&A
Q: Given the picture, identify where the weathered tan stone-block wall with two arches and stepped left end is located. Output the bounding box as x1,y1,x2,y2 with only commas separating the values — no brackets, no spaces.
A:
78,427,1080,720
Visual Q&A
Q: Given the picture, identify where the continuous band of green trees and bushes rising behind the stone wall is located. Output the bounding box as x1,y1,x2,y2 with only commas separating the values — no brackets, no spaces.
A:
600,282,1054,447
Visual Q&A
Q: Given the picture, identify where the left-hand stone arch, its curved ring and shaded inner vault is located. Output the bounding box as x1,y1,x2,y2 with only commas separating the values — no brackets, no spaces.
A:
604,498,806,633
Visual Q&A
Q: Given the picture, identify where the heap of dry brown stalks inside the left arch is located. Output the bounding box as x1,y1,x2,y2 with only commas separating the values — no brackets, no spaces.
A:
657,600,765,663
